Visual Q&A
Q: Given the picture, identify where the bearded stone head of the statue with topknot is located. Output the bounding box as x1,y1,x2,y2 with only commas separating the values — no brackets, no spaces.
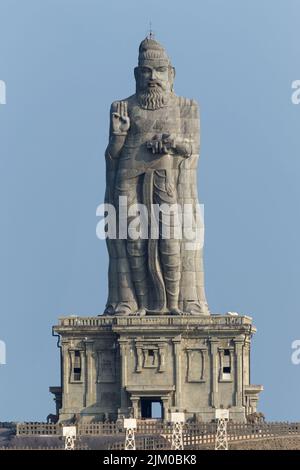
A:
134,37,175,110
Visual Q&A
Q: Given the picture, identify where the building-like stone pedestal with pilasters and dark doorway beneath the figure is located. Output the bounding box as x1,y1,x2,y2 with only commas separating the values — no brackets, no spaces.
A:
54,315,262,421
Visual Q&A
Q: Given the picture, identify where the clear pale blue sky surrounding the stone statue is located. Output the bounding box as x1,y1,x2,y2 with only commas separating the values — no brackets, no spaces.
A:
0,0,300,421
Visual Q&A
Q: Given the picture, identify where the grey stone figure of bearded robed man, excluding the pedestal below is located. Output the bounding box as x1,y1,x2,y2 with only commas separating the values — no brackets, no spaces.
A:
105,36,209,315
